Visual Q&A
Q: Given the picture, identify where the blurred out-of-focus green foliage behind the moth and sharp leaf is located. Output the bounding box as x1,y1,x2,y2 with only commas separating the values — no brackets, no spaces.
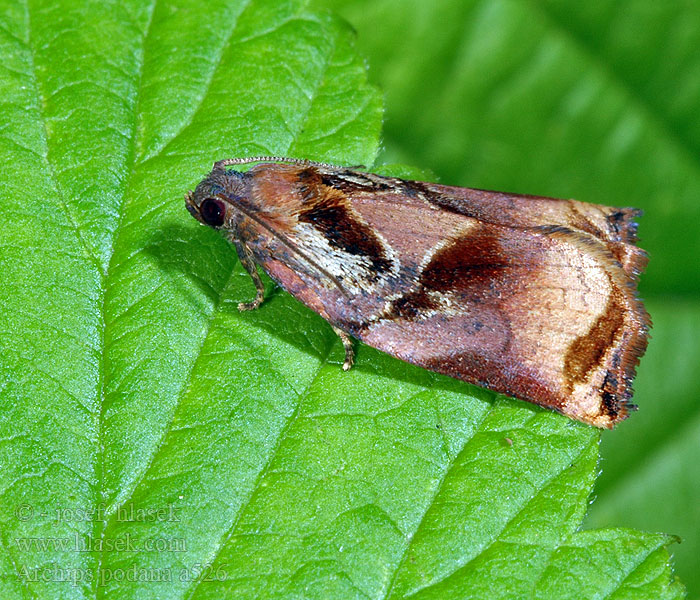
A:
319,0,700,597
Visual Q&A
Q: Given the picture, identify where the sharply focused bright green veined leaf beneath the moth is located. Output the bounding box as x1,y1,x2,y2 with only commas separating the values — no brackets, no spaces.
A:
0,0,683,599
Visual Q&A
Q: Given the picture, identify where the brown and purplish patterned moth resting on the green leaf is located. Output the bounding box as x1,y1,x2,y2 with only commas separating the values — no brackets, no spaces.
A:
186,157,650,427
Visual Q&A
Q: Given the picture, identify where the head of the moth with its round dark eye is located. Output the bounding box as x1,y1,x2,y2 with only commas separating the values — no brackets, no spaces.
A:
185,166,245,229
